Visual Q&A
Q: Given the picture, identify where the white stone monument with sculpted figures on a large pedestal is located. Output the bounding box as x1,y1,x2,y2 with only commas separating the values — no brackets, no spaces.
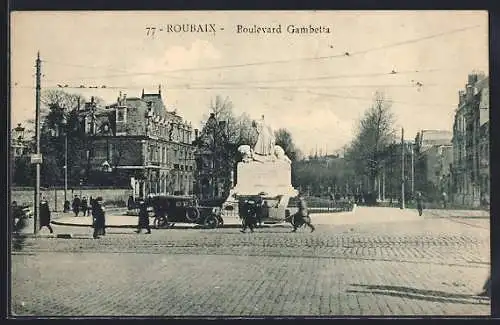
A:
225,116,298,211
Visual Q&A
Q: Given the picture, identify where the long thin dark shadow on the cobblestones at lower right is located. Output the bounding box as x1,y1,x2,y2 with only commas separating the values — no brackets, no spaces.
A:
347,284,490,305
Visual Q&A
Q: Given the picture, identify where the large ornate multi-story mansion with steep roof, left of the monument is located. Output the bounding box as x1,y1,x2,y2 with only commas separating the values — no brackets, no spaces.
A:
75,87,195,196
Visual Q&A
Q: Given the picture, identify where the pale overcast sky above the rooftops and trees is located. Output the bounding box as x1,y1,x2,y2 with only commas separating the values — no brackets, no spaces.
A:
11,11,488,153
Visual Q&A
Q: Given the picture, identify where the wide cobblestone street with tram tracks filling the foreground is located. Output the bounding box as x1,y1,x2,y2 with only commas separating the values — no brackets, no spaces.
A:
12,209,490,316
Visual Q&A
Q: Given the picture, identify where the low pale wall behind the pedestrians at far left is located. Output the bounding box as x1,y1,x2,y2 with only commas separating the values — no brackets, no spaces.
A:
10,188,132,211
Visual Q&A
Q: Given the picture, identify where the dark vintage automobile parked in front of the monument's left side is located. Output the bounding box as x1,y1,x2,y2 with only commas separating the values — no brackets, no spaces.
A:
146,195,224,228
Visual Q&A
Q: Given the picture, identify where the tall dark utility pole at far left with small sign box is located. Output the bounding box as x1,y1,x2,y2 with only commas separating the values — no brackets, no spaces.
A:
33,52,41,235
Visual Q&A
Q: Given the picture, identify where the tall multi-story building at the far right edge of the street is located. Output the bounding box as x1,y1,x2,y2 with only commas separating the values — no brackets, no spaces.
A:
452,73,489,206
